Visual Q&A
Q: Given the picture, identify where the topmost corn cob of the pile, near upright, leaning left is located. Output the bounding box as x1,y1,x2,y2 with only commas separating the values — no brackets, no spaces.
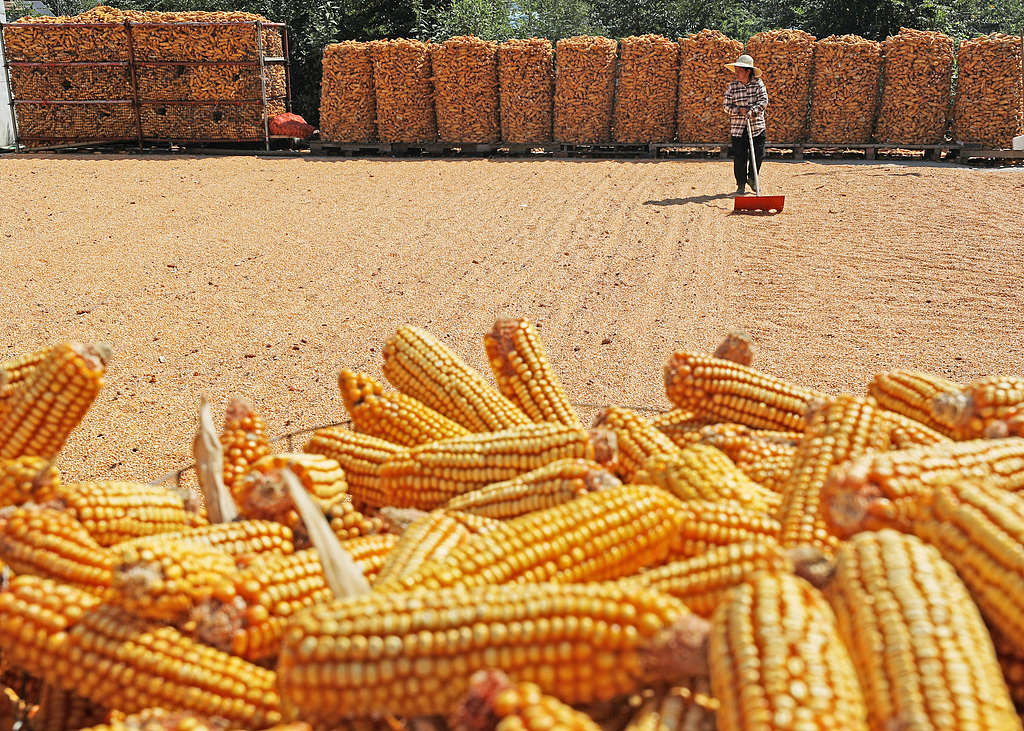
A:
483,317,583,429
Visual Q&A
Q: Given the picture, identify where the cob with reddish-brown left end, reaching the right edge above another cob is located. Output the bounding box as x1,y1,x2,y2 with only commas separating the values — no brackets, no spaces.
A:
822,437,1024,539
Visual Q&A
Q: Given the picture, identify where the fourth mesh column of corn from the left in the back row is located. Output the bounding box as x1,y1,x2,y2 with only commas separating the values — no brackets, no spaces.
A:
498,38,555,142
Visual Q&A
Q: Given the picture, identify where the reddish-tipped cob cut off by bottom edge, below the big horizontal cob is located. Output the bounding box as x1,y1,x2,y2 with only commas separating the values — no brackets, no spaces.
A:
449,671,601,731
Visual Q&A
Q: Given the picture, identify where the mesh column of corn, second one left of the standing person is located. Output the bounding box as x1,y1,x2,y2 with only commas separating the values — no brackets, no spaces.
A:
611,35,679,143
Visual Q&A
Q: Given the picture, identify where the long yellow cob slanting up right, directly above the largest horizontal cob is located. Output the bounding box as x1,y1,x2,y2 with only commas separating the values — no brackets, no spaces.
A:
387,485,679,590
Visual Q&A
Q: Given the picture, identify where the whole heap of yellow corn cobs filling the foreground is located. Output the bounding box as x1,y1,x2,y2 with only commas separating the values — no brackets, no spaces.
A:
0,317,1024,731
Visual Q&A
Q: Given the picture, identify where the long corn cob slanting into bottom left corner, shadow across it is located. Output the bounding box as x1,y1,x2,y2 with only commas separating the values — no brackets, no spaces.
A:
0,575,281,729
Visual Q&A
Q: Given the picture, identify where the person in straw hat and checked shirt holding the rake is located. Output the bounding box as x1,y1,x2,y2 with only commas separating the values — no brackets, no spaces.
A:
725,53,768,196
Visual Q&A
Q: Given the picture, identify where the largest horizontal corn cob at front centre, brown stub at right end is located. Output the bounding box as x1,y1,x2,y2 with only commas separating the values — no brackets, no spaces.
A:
278,583,707,723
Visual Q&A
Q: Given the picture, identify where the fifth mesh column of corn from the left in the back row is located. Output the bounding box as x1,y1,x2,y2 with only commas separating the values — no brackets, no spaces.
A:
554,36,618,144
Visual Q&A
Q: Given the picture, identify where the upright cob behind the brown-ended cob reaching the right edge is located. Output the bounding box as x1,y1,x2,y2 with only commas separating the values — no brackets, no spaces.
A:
778,395,890,553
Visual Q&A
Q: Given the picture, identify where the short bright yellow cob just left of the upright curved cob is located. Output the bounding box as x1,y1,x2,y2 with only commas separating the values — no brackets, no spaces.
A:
620,441,781,514
